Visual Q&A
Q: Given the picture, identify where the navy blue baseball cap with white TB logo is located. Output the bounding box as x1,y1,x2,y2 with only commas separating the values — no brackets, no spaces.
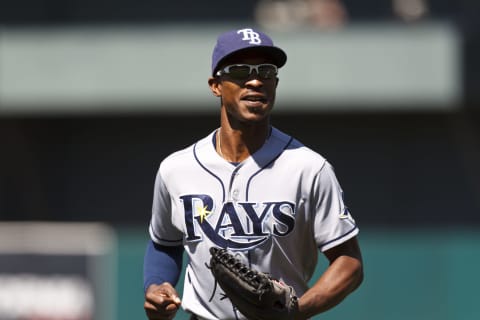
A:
212,28,287,75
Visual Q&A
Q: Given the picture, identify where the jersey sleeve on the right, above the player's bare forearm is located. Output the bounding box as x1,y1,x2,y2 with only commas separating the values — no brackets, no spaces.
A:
314,162,359,251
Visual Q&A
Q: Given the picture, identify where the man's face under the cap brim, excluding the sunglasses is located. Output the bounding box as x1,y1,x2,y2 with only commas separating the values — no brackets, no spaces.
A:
209,53,278,122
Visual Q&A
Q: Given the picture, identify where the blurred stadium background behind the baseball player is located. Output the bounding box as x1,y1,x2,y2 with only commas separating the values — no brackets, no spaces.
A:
0,0,480,320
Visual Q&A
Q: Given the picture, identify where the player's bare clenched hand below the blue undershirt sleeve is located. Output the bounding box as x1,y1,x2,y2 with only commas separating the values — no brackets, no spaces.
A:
143,282,181,320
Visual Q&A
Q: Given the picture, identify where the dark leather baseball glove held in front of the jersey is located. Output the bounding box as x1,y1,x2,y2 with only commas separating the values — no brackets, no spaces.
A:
209,247,298,320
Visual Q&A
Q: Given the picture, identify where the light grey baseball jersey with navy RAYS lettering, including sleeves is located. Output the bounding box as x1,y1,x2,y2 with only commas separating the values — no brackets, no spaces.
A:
150,128,358,320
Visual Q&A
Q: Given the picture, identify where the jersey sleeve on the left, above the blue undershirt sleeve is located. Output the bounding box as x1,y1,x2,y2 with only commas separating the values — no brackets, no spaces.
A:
149,165,183,246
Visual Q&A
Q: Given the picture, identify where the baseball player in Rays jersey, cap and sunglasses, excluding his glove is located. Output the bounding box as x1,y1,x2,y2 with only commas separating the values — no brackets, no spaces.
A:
144,28,363,320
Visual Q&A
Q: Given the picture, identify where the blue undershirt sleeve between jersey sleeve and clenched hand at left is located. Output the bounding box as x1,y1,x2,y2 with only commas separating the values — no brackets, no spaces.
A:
143,240,184,291
